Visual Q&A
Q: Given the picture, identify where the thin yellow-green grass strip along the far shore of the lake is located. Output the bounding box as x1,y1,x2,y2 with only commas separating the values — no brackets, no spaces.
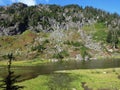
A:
0,55,120,66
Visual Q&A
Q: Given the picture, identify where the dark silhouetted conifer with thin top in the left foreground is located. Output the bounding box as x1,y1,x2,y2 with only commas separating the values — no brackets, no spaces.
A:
0,53,23,90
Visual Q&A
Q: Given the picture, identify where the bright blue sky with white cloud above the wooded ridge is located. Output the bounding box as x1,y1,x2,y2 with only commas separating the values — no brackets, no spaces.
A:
0,0,120,15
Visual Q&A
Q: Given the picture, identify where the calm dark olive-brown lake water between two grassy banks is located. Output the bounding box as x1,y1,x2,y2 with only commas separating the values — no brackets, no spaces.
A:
0,59,120,81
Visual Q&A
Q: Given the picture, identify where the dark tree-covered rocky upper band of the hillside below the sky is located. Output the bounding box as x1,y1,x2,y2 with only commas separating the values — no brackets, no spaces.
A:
0,3,120,36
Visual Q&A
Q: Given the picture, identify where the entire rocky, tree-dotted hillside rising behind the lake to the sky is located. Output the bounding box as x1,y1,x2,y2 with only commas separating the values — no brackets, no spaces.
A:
0,3,120,60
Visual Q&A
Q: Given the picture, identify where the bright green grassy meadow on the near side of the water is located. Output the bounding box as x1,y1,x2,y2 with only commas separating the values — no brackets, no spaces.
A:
19,68,120,90
